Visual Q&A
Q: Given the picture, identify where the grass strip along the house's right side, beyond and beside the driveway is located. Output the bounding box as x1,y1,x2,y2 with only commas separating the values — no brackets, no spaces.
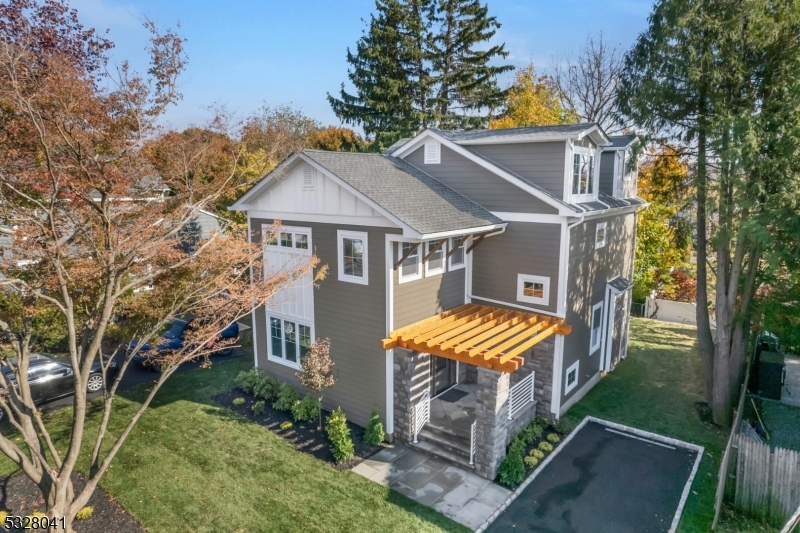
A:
566,319,771,533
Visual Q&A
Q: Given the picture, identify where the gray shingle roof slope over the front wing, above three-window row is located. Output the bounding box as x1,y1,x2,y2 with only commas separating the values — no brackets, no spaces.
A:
302,150,503,234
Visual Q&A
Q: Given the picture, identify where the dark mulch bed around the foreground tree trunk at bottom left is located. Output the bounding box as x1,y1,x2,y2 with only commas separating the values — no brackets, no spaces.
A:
0,474,146,533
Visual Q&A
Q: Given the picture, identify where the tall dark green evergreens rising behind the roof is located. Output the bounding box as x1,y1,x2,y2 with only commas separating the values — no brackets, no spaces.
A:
328,0,512,141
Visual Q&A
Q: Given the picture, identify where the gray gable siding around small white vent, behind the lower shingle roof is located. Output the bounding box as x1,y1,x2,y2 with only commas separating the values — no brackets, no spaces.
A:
404,146,558,214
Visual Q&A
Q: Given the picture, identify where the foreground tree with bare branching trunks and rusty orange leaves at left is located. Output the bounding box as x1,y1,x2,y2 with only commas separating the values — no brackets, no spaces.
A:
0,0,324,531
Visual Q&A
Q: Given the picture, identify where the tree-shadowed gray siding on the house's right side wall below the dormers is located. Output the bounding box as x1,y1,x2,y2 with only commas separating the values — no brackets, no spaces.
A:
561,213,636,405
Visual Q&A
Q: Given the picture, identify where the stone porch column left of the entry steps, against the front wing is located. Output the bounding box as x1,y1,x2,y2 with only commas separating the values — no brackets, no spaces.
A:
394,348,430,442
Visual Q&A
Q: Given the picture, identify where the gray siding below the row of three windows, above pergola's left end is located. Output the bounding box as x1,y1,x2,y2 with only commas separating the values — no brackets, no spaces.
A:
392,243,466,329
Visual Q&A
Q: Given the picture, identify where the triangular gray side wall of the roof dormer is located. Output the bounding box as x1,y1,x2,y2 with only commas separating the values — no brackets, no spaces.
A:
469,141,567,198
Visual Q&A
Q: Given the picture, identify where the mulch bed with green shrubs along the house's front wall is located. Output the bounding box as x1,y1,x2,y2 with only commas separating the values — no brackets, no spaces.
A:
212,388,384,471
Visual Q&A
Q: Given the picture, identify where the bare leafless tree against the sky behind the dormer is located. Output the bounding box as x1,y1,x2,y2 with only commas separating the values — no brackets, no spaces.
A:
552,33,627,135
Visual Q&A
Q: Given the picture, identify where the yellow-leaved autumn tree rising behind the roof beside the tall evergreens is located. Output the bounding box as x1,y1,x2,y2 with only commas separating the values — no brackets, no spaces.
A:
489,63,577,129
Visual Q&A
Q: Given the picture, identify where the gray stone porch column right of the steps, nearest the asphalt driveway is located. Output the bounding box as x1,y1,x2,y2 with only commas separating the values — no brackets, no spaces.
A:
475,368,510,479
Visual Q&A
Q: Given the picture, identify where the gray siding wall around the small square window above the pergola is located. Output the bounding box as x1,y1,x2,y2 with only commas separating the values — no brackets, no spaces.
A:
471,222,561,313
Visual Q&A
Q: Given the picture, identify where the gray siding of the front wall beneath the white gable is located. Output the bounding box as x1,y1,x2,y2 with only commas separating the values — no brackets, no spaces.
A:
251,214,400,426
